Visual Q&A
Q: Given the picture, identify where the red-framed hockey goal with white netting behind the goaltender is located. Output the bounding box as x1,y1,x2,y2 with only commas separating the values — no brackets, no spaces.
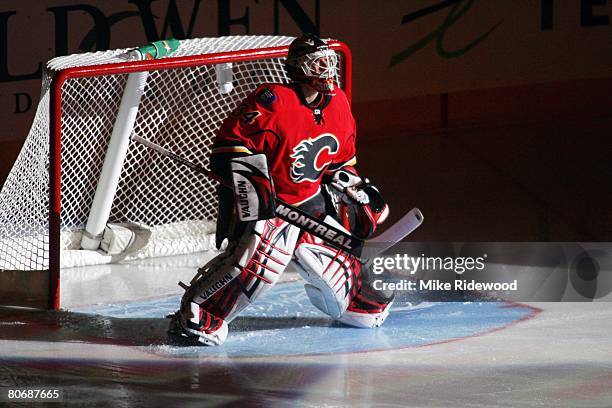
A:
0,36,352,309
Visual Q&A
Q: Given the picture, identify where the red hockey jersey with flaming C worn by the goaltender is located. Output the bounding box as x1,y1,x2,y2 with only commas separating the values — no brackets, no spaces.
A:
212,84,356,205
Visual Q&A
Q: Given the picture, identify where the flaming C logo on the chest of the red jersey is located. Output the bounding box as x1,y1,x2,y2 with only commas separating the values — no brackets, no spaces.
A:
291,133,340,183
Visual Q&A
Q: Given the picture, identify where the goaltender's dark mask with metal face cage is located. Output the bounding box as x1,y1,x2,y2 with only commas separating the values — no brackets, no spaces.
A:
286,34,338,95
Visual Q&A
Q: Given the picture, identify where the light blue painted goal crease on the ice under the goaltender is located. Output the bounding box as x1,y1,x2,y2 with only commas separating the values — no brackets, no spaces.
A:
69,282,535,357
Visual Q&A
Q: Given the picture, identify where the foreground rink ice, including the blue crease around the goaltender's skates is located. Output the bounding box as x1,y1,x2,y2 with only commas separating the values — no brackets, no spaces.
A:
0,282,612,408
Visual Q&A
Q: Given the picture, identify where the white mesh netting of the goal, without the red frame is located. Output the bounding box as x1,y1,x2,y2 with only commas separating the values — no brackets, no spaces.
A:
0,36,340,270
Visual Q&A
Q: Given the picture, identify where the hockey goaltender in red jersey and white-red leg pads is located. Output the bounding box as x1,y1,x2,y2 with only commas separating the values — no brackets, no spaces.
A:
169,35,394,345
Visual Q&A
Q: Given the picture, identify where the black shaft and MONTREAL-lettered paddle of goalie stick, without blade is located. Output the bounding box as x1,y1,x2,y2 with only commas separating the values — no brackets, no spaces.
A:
132,135,363,257
